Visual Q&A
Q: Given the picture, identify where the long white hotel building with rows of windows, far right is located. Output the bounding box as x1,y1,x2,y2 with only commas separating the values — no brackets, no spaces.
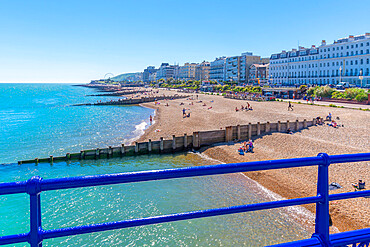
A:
269,33,370,86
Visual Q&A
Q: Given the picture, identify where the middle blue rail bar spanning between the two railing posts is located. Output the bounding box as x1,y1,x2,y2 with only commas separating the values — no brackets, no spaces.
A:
42,196,321,239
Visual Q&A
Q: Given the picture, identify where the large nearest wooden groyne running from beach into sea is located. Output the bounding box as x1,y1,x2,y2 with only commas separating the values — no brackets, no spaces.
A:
18,119,316,164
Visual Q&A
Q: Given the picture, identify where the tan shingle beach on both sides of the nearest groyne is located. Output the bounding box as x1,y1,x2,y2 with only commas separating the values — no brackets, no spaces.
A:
129,89,370,231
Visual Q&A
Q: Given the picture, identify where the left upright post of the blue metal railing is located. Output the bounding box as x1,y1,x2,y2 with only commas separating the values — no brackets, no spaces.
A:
27,176,42,247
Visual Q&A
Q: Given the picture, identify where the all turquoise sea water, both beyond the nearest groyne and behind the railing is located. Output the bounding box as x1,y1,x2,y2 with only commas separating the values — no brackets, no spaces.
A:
0,84,310,246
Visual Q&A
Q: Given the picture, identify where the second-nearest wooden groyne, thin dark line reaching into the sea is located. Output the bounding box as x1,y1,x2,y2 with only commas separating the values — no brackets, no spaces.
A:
74,95,189,106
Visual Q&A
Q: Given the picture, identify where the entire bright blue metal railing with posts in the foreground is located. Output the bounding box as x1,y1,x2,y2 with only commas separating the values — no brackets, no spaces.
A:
0,153,370,247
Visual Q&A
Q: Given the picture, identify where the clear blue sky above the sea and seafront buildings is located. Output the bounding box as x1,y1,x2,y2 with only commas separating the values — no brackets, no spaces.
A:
0,0,370,82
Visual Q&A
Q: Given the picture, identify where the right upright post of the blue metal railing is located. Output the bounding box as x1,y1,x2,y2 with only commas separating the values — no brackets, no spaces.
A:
312,153,331,246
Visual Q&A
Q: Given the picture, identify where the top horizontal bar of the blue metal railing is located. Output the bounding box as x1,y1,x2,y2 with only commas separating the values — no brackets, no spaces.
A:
0,153,370,195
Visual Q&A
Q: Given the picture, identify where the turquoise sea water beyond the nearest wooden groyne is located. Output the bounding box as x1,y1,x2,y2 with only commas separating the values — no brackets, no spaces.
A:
0,84,154,164
